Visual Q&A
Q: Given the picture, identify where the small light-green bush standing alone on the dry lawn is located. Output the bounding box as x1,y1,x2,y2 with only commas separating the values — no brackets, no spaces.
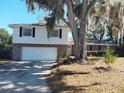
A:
103,49,117,67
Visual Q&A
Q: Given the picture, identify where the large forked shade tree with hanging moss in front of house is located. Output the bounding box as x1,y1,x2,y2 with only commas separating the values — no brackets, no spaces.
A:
26,0,104,61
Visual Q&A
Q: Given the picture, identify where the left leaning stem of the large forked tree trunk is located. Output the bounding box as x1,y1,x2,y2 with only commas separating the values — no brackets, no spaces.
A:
66,0,81,60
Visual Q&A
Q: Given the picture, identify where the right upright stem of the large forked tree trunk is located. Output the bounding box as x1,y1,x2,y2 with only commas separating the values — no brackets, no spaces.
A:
79,0,88,62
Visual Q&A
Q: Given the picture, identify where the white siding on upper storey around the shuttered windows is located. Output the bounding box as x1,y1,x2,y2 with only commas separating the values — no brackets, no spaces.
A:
13,26,69,44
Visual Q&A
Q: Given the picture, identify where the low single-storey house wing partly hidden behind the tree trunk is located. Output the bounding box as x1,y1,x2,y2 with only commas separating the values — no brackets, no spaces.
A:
69,41,119,56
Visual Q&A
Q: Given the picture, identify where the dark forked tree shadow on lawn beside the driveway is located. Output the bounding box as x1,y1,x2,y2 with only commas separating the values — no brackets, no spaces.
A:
48,71,102,93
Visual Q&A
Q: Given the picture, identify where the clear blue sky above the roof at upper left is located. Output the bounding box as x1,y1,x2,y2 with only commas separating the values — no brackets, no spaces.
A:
0,0,46,34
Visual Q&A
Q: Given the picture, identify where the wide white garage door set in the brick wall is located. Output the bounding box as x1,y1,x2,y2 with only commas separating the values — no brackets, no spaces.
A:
22,47,57,60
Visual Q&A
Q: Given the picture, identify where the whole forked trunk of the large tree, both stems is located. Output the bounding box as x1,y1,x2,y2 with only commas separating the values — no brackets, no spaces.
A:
65,0,97,61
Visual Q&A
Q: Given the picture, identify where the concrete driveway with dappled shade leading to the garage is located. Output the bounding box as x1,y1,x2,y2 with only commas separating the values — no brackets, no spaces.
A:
0,62,53,93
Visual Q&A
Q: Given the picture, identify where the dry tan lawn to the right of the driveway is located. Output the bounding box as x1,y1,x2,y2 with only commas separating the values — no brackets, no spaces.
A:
48,58,124,93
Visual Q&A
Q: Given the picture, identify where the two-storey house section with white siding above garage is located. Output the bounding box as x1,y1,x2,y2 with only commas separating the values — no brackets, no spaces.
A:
9,23,70,60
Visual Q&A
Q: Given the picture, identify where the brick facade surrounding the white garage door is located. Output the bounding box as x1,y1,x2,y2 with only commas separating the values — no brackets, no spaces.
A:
13,44,70,60
